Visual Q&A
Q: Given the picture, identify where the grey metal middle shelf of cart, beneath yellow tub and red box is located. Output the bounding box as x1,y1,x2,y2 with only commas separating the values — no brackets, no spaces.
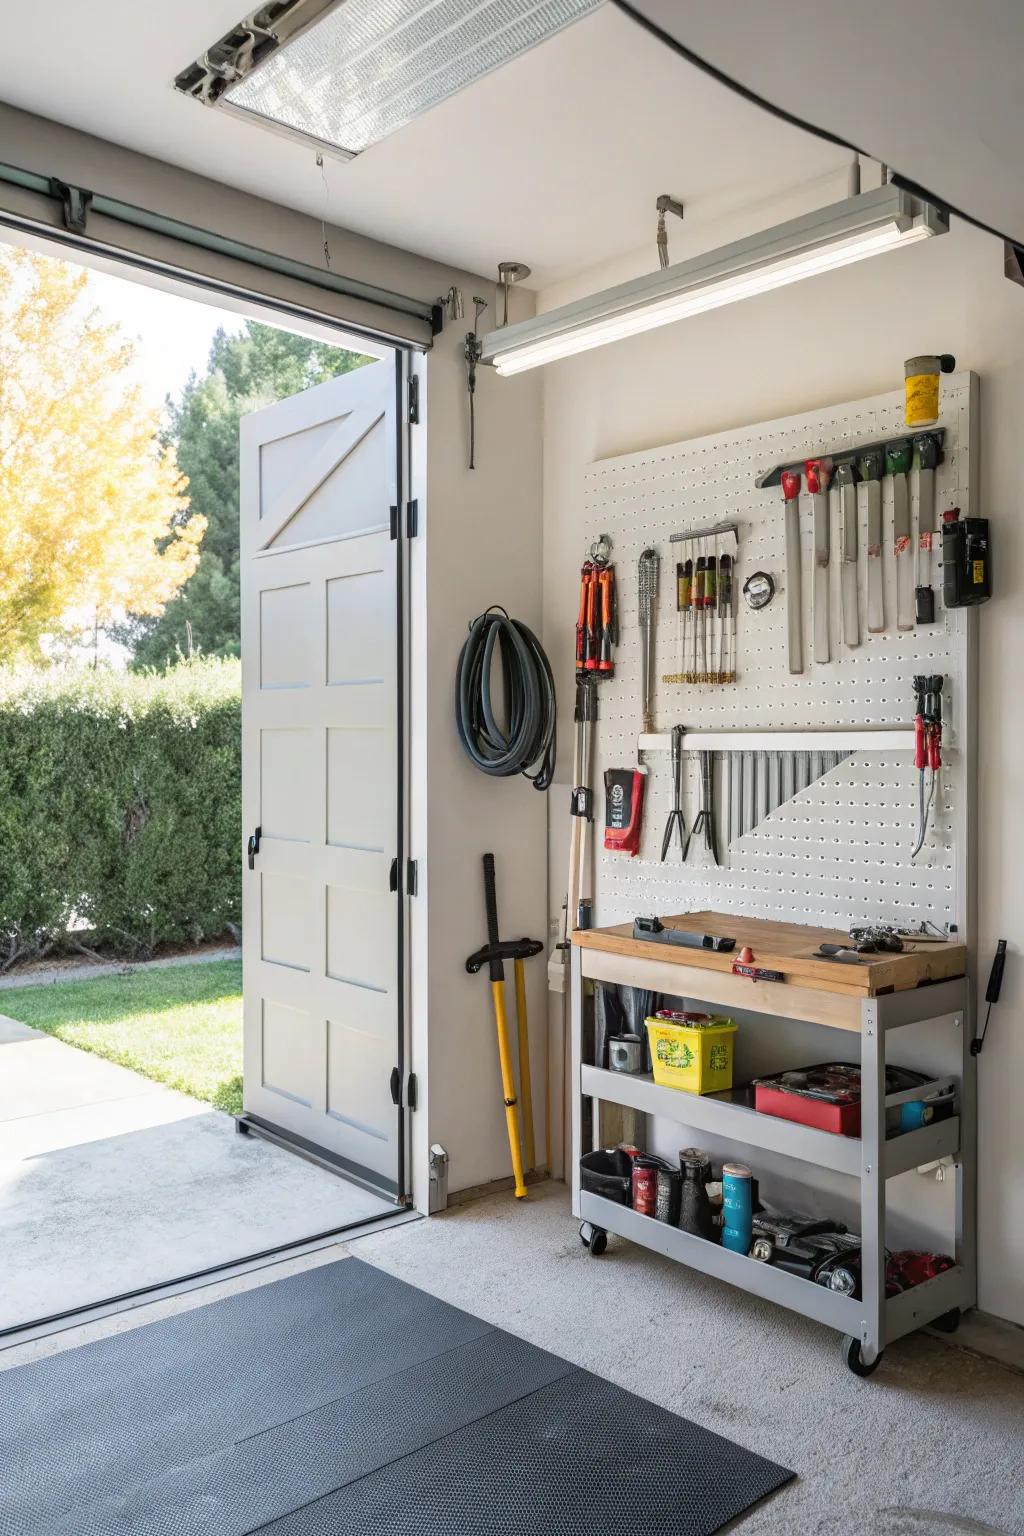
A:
580,1066,960,1178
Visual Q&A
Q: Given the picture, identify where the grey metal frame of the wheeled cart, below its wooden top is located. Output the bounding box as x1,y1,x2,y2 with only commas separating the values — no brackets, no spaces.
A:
571,935,976,1375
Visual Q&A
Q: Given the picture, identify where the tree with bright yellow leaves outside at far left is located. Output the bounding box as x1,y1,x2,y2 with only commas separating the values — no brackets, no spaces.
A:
0,247,206,664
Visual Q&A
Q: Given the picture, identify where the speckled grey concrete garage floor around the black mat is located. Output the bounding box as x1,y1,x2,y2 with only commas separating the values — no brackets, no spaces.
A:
0,1184,1024,1536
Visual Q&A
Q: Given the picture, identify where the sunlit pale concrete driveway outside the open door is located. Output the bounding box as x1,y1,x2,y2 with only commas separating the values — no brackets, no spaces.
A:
0,1015,395,1329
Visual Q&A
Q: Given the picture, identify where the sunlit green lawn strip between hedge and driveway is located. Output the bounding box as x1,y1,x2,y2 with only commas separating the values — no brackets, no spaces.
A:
0,960,243,1114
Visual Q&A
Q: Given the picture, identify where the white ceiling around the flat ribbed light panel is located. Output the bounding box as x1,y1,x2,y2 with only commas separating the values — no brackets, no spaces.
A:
0,0,847,287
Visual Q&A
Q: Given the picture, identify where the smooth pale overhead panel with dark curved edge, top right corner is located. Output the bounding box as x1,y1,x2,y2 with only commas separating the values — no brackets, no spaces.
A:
633,0,1024,241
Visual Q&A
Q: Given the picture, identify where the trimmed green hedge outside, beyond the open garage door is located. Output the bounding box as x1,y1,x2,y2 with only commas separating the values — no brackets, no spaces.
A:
0,659,241,969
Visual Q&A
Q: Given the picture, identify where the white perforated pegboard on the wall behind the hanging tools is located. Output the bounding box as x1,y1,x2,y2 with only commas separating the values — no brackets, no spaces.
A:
585,373,976,931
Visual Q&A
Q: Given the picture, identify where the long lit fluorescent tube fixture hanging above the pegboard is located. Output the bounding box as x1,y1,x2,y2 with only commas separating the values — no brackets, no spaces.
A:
481,186,949,375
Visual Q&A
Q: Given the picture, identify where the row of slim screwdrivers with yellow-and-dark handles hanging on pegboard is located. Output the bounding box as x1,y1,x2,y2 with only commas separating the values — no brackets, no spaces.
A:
662,522,740,684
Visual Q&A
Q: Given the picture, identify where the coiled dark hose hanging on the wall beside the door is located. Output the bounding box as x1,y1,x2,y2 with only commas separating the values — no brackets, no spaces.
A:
454,608,554,790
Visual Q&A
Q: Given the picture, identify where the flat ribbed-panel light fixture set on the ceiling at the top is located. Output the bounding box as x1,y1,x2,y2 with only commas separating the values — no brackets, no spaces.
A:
175,0,602,160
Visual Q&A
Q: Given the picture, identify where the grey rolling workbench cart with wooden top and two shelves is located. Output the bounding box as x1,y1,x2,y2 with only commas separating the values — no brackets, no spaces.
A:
571,912,976,1375
